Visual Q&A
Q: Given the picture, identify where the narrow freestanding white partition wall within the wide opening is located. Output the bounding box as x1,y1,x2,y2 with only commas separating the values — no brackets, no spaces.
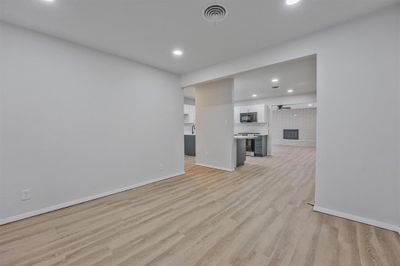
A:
196,79,236,171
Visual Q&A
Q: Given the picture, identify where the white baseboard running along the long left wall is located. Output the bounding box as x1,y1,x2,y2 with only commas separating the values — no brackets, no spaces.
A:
0,172,185,225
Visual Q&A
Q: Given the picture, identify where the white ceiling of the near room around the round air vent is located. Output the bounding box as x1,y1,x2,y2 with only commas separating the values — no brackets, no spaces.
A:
0,0,400,73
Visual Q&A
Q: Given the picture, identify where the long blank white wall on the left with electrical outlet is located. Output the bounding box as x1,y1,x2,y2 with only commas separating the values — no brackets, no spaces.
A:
0,21,184,222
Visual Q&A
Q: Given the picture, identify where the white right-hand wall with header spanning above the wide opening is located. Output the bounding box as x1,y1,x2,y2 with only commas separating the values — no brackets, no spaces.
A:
181,5,400,229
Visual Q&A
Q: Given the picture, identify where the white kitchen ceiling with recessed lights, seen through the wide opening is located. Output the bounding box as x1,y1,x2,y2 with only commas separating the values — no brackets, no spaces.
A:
184,56,317,102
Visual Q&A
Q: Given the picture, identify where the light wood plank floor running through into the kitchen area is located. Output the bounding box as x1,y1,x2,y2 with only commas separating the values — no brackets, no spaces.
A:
0,146,400,266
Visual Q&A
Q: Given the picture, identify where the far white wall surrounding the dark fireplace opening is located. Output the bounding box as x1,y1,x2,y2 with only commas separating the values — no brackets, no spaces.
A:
270,108,317,147
